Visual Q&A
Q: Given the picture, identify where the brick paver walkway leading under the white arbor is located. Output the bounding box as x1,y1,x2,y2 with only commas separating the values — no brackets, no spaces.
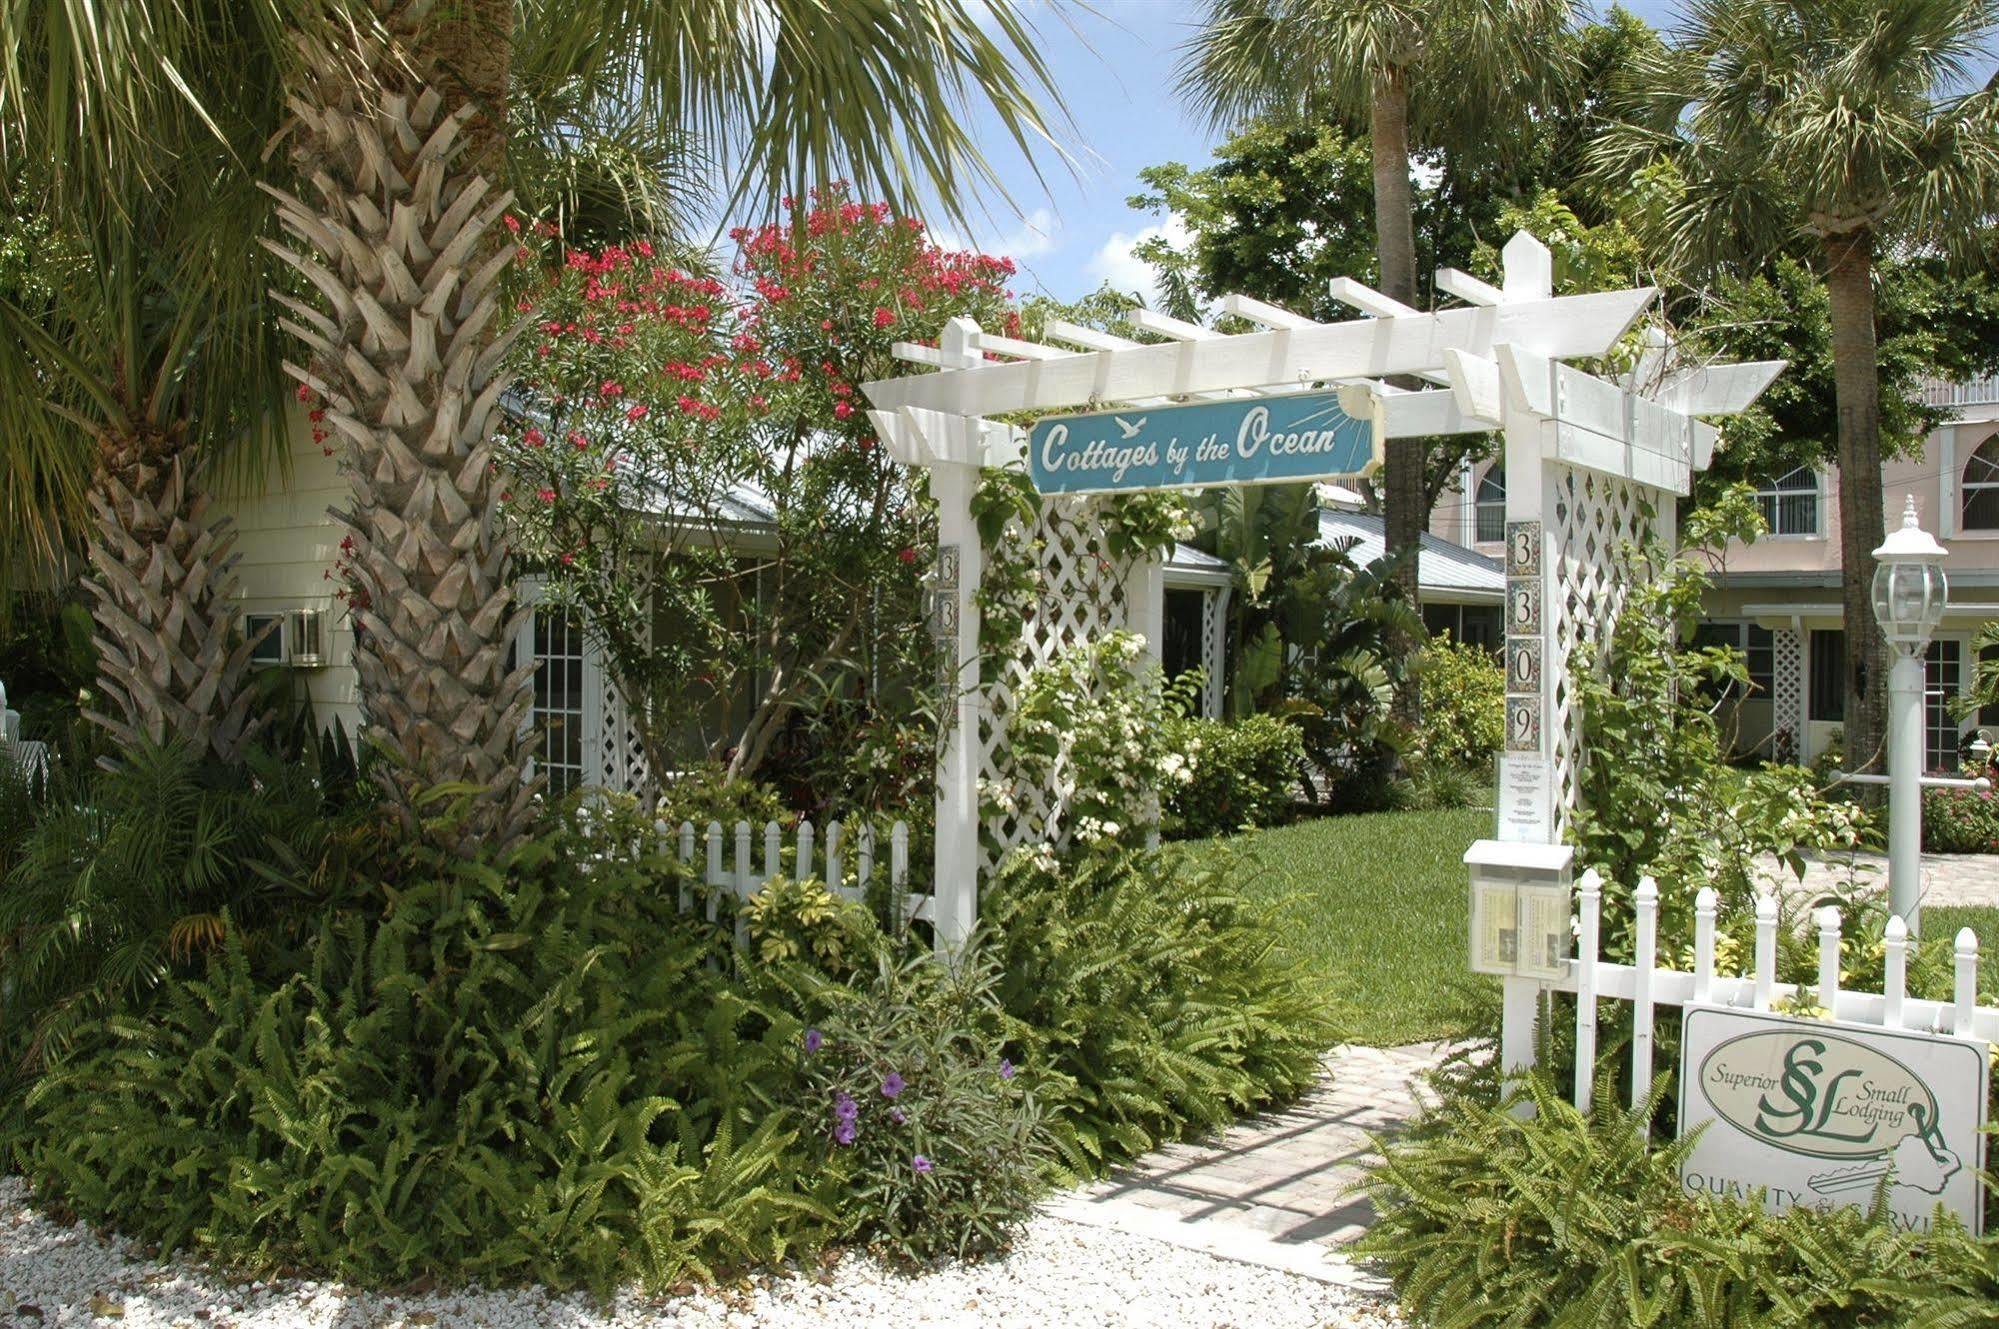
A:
1055,1043,1445,1285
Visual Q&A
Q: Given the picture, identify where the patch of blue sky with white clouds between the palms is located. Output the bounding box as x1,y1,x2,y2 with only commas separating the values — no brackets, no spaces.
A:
915,0,1943,300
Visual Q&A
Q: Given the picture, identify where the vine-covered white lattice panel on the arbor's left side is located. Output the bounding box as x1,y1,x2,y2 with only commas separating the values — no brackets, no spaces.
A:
980,498,1131,871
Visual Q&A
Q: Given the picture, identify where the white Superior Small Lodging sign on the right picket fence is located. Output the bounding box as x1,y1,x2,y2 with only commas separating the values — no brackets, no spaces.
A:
1679,1005,1987,1233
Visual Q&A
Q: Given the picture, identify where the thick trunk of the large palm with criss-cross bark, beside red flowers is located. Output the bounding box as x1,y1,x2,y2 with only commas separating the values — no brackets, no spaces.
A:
274,0,534,849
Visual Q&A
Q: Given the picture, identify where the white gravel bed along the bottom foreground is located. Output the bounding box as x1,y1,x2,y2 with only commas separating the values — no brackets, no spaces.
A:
0,1177,1401,1329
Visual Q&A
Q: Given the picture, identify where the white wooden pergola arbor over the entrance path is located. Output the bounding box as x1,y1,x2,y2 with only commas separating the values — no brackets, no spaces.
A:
864,232,1783,947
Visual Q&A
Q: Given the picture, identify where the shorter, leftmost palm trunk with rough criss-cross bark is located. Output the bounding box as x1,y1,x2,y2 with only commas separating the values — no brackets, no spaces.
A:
86,419,256,761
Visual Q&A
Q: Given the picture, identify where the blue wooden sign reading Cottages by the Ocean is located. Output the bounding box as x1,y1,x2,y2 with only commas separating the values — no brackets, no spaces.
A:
1027,392,1381,494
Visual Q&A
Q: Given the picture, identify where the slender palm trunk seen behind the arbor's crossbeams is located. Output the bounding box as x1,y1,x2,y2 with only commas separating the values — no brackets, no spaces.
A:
1369,66,1429,725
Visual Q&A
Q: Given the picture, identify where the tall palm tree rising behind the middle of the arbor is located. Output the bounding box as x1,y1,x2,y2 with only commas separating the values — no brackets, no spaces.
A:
1179,0,1573,719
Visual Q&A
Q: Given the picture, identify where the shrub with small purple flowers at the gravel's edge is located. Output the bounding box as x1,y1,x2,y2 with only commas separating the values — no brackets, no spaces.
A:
800,955,1049,1261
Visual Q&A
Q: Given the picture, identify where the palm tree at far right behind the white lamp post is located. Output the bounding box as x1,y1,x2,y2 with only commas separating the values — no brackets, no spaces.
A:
1593,0,1999,783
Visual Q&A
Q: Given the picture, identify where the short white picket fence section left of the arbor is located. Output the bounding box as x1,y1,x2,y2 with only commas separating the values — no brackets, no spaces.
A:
654,819,936,941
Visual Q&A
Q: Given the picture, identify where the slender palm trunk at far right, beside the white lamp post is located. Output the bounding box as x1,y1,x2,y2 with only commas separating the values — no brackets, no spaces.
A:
1823,228,1887,771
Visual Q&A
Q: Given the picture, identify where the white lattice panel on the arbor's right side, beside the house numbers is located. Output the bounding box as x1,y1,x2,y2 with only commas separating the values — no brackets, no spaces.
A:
1545,460,1673,829
